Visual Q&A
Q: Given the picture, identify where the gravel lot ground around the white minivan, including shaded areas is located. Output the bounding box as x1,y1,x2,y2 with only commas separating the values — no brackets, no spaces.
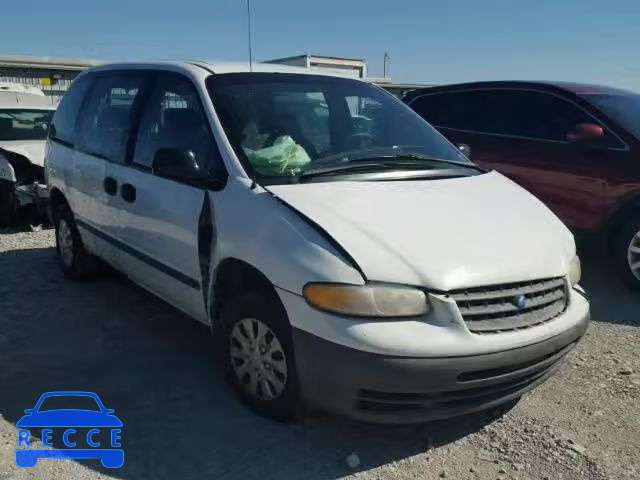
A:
0,231,640,480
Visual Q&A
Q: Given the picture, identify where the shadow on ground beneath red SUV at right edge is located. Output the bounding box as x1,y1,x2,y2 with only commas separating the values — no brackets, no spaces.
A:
579,240,640,326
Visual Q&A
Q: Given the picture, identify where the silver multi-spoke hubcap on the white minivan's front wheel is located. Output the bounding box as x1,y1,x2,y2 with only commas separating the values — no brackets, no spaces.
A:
229,318,287,400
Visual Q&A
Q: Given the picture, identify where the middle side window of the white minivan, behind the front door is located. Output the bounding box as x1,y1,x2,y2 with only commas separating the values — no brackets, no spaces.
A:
78,72,145,162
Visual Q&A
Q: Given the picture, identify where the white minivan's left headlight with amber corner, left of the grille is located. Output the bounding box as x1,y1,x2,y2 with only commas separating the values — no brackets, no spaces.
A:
303,283,429,317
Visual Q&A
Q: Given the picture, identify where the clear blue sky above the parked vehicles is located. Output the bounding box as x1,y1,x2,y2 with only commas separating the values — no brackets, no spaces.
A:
0,0,640,91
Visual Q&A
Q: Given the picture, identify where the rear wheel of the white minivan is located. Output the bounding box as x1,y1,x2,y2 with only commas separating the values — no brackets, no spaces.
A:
54,203,98,279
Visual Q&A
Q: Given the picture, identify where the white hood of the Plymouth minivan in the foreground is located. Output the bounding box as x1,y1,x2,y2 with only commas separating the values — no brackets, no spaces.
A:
268,172,575,291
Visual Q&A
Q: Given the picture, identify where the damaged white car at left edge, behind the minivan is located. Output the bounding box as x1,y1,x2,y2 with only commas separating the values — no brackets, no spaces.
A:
0,83,55,227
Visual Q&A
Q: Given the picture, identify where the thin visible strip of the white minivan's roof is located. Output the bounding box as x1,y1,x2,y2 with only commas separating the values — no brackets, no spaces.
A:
85,60,364,80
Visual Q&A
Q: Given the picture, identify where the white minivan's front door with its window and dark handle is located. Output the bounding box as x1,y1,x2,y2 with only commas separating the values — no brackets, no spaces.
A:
110,73,224,323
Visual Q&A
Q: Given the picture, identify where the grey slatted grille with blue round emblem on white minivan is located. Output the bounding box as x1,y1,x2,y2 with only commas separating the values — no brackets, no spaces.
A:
450,278,567,333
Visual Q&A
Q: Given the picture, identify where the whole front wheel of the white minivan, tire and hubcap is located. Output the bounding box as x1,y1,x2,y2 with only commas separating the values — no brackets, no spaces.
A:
220,292,301,422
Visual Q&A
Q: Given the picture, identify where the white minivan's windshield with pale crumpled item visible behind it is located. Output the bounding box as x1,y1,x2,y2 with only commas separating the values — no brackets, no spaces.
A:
208,73,471,184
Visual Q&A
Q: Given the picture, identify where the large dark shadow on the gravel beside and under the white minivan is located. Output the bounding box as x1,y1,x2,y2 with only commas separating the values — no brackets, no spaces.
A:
0,248,500,479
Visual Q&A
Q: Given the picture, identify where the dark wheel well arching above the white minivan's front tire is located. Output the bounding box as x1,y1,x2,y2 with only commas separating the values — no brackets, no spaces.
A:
211,258,284,325
